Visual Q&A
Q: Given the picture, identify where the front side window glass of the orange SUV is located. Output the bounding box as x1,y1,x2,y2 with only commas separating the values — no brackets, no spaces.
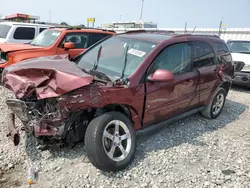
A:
60,33,89,49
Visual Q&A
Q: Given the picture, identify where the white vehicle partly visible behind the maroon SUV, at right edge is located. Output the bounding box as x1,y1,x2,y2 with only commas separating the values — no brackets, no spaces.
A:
227,40,250,88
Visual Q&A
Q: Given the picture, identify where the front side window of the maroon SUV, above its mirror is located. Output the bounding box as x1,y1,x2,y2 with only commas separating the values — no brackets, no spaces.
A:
149,43,191,74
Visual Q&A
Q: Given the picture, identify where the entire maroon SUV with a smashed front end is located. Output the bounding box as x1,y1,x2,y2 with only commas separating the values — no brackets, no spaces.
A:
3,31,234,171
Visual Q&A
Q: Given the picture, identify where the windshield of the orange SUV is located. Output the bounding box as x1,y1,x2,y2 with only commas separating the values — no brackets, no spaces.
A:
30,29,61,46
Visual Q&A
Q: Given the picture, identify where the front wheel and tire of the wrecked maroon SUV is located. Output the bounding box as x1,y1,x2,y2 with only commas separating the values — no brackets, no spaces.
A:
85,112,136,171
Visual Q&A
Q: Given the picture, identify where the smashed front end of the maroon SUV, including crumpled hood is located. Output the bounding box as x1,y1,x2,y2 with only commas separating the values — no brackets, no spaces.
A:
2,59,97,145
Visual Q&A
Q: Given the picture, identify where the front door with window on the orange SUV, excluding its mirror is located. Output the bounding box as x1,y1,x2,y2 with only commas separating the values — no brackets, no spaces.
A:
57,32,90,58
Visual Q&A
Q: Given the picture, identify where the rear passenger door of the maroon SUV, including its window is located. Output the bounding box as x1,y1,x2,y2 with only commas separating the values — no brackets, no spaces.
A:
192,41,220,105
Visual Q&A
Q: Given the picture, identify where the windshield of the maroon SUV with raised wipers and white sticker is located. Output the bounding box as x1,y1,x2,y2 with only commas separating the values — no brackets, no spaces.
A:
77,36,156,78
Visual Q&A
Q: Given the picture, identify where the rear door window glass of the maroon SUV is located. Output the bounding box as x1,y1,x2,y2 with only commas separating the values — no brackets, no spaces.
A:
192,42,215,68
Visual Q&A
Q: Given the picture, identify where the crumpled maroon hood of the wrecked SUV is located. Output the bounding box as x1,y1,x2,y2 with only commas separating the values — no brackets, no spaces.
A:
2,56,93,99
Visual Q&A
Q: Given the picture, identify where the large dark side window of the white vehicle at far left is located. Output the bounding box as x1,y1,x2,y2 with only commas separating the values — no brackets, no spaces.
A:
13,27,35,40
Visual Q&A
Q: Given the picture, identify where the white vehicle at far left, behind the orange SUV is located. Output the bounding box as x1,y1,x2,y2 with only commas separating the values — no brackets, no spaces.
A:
0,22,53,43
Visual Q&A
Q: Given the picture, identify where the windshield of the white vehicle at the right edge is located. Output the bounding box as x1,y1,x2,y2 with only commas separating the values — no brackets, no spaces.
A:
227,41,250,53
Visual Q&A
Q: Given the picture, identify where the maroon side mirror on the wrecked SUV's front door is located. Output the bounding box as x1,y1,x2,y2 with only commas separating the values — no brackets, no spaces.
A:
148,69,174,82
